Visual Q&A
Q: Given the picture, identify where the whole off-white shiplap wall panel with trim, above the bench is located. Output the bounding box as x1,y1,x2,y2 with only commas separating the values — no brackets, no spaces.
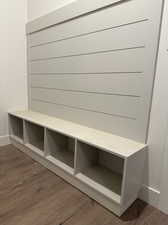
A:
27,0,163,142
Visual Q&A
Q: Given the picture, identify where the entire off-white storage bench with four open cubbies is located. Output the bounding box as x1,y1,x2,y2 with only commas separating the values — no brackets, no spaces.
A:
9,111,146,216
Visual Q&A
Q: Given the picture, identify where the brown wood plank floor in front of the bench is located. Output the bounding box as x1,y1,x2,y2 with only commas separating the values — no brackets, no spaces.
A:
0,145,168,225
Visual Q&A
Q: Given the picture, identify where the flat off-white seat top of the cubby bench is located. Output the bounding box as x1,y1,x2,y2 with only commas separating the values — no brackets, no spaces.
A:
9,111,147,158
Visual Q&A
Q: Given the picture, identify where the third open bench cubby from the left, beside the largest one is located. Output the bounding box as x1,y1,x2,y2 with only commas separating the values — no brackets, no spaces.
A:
46,129,75,172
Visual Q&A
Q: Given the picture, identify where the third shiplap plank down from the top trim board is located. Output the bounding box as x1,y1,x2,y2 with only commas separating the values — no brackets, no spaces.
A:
29,48,146,73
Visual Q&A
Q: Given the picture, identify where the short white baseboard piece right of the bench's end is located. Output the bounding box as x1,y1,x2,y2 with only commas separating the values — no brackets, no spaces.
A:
139,185,160,208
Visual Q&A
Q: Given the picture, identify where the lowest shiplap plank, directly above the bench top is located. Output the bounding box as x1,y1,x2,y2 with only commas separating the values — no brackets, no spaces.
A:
31,100,145,142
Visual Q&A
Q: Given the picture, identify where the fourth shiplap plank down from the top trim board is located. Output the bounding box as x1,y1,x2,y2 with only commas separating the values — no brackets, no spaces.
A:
30,73,144,96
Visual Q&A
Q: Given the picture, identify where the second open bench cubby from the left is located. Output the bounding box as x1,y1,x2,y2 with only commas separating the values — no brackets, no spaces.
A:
25,121,44,151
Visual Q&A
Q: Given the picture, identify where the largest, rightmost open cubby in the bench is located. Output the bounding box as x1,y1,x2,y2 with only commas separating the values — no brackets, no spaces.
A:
77,141,124,201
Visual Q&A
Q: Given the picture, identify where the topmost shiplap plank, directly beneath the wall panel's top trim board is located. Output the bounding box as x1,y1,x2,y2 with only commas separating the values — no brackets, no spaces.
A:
28,0,149,46
